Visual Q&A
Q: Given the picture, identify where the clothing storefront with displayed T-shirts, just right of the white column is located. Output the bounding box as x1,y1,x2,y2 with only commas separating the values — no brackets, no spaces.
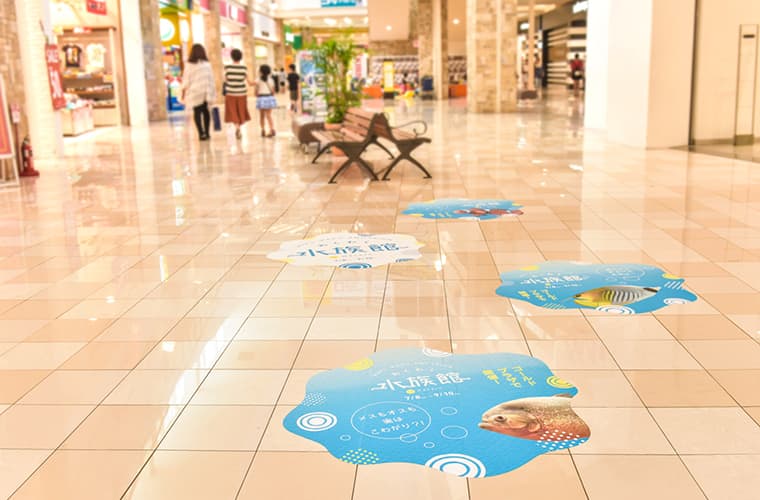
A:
51,0,129,136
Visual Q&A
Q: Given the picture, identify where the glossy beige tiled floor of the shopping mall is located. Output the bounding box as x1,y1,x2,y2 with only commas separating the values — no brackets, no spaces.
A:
0,91,760,500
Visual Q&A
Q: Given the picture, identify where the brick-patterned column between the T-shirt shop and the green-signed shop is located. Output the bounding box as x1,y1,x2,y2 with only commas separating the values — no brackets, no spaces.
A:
138,0,167,122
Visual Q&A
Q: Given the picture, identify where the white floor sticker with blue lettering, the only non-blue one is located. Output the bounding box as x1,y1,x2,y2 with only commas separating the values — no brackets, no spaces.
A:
267,233,423,269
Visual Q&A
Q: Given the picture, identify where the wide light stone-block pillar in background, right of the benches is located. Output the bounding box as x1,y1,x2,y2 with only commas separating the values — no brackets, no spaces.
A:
467,0,517,113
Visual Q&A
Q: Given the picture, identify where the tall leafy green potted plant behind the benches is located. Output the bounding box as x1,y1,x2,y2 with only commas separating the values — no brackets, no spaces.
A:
311,35,361,124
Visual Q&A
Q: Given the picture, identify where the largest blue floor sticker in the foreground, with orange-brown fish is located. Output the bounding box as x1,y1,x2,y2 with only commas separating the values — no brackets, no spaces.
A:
283,348,591,477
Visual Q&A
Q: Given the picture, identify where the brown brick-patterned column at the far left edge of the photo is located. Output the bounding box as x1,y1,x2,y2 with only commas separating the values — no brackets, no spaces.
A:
0,2,29,140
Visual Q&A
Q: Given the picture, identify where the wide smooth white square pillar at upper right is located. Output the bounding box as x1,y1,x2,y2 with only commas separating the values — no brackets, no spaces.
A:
585,0,694,148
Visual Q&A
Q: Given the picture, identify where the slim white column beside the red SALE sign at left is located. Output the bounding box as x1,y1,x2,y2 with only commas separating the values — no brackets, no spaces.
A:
13,0,63,158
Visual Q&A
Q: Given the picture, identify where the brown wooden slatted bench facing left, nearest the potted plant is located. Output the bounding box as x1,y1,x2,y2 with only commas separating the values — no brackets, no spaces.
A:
312,108,393,184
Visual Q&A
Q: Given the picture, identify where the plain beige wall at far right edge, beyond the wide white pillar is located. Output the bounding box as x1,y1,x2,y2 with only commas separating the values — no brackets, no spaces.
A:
692,0,760,142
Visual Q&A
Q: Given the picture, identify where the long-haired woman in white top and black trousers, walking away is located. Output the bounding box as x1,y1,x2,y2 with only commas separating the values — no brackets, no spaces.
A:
182,43,216,141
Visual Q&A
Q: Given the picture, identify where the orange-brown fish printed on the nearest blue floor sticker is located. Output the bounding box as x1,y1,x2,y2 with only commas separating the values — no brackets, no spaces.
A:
478,394,591,442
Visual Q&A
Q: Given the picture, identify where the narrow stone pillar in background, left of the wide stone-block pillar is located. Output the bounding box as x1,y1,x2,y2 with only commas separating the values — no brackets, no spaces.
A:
417,0,449,99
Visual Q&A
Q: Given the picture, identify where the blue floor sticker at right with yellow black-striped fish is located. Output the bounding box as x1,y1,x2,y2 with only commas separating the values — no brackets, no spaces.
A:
496,262,697,314
